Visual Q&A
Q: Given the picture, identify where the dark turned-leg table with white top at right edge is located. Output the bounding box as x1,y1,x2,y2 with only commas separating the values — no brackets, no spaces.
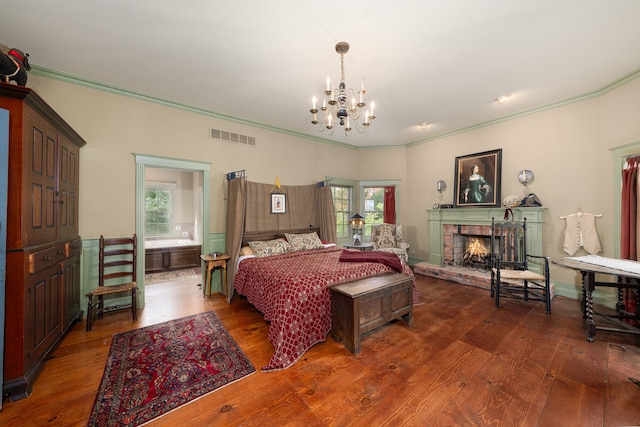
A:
552,258,640,342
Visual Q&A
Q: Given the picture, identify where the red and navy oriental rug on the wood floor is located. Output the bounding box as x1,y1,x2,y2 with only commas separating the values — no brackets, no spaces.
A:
88,311,255,426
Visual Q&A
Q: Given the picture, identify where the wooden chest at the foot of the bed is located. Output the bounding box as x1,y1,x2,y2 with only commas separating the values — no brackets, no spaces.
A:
330,273,413,354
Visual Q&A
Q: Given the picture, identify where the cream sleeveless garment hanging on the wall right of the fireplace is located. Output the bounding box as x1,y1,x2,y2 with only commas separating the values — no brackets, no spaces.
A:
560,208,602,255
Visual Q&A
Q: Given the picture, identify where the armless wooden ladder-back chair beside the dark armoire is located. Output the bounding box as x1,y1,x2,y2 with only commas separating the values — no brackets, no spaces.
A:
86,234,138,331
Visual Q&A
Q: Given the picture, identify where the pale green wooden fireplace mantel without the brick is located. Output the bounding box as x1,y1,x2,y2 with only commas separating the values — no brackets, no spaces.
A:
428,207,546,265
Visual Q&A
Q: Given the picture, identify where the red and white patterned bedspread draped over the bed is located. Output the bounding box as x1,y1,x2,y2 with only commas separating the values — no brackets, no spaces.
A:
234,247,416,371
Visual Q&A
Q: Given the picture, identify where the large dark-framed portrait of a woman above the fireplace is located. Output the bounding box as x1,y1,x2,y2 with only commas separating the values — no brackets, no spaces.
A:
453,149,502,207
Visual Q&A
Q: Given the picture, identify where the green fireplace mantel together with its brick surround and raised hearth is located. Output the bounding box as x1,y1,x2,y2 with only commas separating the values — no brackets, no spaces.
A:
414,208,545,290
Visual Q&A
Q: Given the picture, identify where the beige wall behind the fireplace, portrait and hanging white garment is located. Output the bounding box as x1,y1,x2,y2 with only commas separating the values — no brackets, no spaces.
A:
405,79,640,294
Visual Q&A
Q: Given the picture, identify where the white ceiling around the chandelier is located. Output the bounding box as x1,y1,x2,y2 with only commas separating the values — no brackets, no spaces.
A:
0,0,640,147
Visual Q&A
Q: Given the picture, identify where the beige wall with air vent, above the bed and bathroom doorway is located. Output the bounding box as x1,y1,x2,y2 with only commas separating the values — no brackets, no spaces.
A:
29,76,358,239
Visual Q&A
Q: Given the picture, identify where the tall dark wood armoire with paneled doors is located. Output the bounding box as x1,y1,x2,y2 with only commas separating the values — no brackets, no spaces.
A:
0,83,86,400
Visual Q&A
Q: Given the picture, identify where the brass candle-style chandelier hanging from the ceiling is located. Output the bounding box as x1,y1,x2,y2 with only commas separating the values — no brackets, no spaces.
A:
309,42,376,135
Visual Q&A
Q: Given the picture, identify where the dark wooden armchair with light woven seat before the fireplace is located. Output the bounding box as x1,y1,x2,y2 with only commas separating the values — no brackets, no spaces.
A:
491,218,551,313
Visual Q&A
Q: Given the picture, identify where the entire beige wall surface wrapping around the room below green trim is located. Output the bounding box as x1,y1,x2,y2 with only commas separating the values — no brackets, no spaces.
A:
22,75,640,294
